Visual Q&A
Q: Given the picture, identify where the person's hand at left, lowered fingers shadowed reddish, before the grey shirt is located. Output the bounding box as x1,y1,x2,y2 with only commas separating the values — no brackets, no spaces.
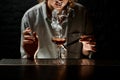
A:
22,27,38,58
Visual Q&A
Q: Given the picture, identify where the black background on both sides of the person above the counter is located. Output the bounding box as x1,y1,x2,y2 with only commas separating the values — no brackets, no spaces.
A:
0,0,120,60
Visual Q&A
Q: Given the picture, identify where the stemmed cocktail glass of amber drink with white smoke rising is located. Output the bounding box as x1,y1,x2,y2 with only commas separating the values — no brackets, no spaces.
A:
51,9,68,63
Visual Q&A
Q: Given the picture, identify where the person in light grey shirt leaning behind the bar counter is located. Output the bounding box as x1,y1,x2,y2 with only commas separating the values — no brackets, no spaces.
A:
21,0,95,62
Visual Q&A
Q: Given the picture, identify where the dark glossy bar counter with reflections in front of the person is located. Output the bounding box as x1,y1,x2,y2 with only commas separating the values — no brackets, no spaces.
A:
0,59,120,80
